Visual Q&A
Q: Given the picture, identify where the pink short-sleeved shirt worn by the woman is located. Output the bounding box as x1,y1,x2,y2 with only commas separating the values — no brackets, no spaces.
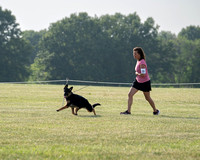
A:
135,59,150,83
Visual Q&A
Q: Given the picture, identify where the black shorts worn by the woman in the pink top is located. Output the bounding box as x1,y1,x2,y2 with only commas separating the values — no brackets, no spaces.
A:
132,79,151,92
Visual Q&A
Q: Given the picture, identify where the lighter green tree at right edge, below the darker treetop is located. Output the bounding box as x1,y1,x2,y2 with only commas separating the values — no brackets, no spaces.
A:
175,37,200,83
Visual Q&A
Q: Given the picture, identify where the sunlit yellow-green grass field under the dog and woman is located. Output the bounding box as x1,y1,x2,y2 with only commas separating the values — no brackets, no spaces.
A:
0,84,200,160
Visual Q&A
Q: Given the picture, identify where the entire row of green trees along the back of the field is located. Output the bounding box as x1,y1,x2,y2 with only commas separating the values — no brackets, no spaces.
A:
0,7,200,83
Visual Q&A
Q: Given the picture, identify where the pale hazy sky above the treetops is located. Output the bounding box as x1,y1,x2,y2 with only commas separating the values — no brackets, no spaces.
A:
0,0,200,34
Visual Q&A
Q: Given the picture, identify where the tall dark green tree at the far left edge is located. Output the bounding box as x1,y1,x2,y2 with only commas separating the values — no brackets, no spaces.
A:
0,7,31,81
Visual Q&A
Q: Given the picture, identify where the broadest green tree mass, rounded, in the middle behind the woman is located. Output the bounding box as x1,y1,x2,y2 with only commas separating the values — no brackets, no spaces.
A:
32,13,162,82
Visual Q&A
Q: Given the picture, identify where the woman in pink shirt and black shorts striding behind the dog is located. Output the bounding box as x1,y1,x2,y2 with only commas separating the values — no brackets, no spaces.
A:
120,47,160,115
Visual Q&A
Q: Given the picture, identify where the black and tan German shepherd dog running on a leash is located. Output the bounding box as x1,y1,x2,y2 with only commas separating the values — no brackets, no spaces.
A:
56,85,101,115
